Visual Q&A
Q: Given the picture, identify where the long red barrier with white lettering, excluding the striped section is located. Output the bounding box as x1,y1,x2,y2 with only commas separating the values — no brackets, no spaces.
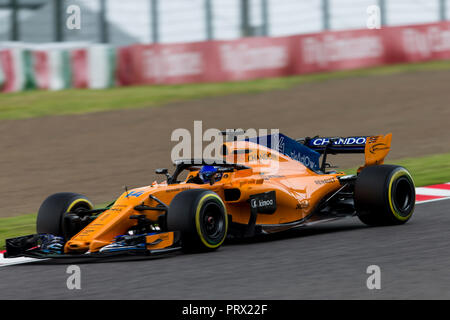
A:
118,22,450,85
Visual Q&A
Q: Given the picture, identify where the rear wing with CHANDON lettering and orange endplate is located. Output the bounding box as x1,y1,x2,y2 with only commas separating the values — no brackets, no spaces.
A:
297,133,392,171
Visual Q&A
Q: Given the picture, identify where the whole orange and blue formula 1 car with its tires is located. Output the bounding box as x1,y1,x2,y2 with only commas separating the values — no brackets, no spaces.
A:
5,134,415,258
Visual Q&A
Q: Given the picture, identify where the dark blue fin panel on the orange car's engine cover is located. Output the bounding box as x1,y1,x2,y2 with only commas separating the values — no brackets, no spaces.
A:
245,133,320,171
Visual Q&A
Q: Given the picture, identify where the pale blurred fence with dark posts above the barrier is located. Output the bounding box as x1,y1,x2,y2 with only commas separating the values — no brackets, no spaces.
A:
0,0,450,45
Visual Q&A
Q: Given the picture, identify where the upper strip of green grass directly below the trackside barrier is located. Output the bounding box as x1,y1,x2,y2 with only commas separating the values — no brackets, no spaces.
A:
0,61,450,119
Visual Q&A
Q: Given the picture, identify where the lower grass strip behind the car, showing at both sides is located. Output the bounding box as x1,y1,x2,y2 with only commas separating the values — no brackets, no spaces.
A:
0,153,450,250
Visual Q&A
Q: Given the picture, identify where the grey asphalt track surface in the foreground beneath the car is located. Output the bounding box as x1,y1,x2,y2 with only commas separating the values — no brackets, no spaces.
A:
0,200,450,300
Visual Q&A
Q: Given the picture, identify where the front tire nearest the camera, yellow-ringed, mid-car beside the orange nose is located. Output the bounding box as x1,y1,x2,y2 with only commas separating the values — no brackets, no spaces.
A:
167,189,228,252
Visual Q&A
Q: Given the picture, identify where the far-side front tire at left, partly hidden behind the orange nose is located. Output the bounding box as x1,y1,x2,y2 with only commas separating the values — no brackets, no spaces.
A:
36,192,94,238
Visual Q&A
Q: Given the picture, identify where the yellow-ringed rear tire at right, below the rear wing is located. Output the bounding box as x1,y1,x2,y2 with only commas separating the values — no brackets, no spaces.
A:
354,165,416,226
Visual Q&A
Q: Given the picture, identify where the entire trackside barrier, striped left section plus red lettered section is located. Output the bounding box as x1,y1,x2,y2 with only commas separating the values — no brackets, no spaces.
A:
4,22,450,92
